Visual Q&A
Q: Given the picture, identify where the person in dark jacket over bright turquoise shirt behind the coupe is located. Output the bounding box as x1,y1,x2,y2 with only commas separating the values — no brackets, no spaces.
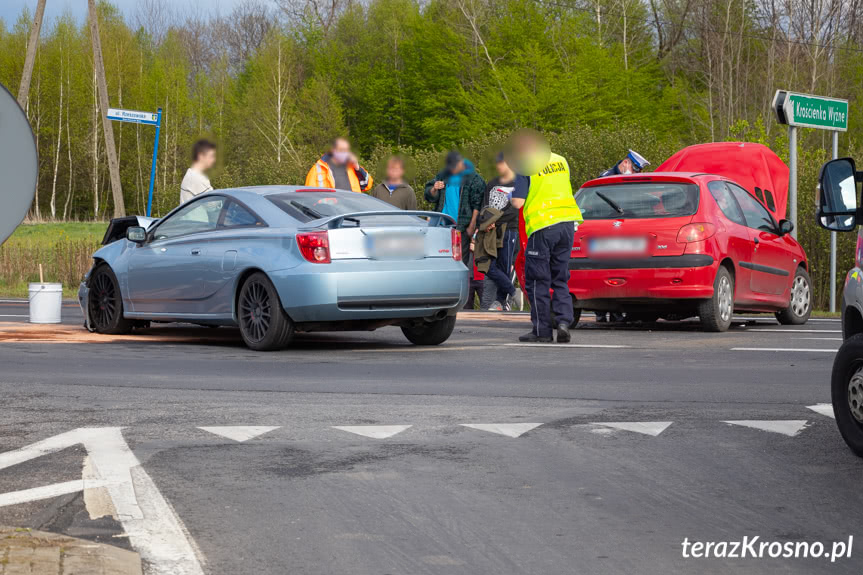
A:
425,150,485,274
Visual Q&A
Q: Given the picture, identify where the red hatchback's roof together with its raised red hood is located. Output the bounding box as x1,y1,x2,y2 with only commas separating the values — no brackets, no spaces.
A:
583,142,789,220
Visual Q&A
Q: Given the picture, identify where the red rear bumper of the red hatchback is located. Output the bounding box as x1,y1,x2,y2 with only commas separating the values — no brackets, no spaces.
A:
569,254,718,301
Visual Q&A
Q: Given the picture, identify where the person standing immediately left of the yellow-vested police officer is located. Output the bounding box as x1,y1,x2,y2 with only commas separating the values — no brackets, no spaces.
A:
483,152,519,311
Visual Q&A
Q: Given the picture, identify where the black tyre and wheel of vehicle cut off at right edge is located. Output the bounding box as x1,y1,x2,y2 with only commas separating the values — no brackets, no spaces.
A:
830,334,863,457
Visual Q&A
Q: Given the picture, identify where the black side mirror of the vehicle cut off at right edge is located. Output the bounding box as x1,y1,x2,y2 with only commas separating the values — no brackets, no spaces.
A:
815,158,863,232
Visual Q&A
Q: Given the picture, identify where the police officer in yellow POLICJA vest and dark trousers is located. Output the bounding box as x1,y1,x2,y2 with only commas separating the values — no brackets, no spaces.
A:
512,133,583,343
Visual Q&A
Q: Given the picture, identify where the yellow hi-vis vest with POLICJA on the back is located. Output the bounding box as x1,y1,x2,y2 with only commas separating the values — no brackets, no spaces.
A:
524,154,584,237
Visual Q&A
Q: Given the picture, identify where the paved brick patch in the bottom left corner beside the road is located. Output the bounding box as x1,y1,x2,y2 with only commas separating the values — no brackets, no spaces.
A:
0,526,142,575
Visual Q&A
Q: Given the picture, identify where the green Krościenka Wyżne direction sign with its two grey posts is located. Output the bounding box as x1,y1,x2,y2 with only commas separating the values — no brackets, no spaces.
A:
773,90,848,312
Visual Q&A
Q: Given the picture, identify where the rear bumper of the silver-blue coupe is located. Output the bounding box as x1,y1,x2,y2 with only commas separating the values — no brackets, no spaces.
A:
270,258,468,322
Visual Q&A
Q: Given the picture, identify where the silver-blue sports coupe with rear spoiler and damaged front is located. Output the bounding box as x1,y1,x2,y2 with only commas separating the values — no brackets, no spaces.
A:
78,186,468,350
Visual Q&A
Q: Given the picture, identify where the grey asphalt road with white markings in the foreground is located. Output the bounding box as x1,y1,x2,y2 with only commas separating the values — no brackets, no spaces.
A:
0,303,863,575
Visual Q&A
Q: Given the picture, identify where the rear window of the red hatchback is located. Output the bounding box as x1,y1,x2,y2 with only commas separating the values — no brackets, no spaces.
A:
575,182,698,220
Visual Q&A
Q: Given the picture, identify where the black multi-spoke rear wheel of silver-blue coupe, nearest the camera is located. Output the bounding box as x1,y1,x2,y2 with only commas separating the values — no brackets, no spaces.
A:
237,273,294,351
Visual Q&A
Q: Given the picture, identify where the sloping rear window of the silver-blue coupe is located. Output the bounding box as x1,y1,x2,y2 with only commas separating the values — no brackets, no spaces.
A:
267,192,423,226
